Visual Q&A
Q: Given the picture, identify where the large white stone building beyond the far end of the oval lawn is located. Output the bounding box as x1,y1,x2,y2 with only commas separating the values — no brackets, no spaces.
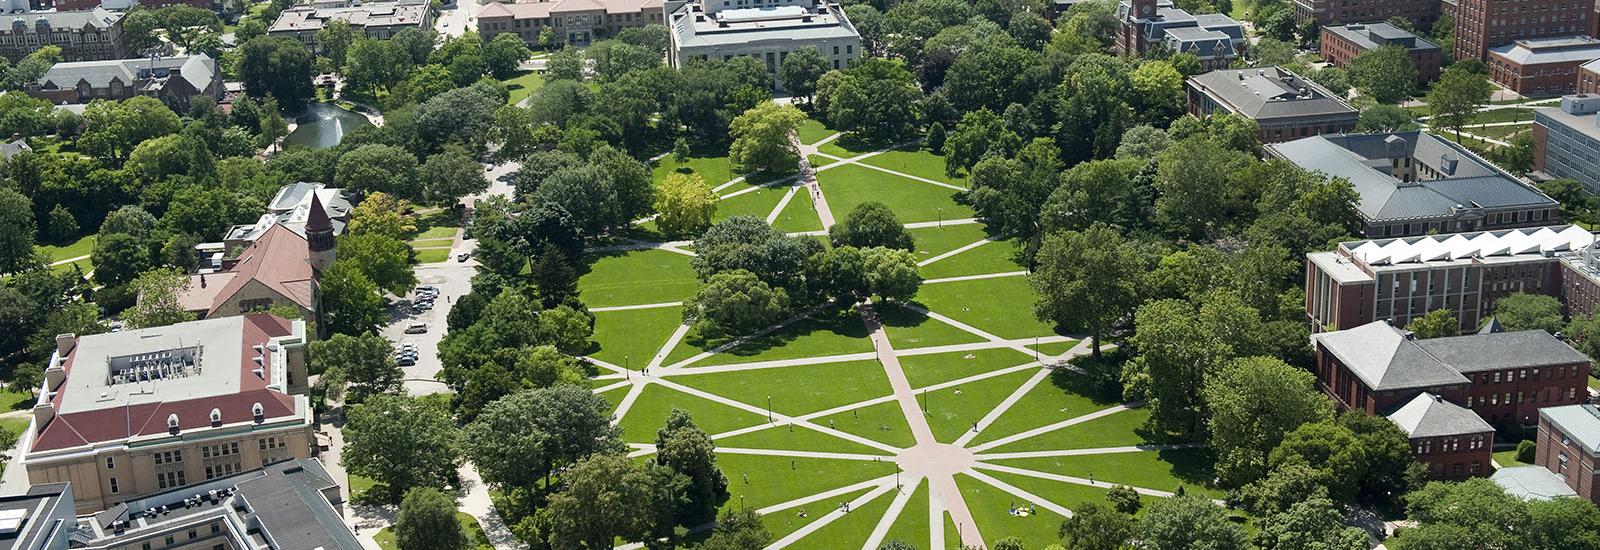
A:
664,0,864,88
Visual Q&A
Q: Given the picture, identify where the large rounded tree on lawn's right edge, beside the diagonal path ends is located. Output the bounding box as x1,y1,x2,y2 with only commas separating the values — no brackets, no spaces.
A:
1029,222,1144,358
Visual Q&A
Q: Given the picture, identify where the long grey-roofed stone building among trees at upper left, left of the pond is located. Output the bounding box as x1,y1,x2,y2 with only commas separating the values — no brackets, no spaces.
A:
24,53,222,112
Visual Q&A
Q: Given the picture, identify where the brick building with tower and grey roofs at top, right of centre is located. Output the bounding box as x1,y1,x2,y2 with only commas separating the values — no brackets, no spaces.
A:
1117,0,1245,70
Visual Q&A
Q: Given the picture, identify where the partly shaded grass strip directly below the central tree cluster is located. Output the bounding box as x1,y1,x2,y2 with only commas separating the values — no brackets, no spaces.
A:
666,306,872,366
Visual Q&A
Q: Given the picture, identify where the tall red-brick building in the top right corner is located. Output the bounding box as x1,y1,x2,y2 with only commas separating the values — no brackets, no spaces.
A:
1454,0,1595,59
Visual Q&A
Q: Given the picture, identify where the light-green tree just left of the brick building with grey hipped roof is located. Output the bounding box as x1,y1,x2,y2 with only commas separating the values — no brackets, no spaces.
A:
1203,357,1333,486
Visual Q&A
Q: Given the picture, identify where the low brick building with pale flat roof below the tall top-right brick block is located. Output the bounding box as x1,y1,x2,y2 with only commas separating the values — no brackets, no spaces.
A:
1486,35,1600,98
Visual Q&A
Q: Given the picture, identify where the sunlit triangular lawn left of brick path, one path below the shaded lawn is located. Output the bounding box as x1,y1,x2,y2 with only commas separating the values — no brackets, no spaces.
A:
672,360,894,416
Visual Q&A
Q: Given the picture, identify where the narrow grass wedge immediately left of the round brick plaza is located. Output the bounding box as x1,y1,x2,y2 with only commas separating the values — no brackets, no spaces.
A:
717,452,894,518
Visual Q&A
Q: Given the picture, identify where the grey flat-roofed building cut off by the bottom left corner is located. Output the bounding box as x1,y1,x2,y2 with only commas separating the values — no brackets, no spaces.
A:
0,459,362,550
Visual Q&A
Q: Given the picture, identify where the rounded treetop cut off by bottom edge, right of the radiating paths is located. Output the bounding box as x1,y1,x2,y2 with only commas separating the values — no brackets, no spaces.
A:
1136,494,1248,550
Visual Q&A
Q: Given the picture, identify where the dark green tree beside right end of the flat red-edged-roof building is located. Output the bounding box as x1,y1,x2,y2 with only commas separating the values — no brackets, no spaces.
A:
307,333,405,405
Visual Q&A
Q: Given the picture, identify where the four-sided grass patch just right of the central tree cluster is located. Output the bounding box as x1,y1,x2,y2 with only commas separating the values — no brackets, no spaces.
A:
917,276,1056,339
